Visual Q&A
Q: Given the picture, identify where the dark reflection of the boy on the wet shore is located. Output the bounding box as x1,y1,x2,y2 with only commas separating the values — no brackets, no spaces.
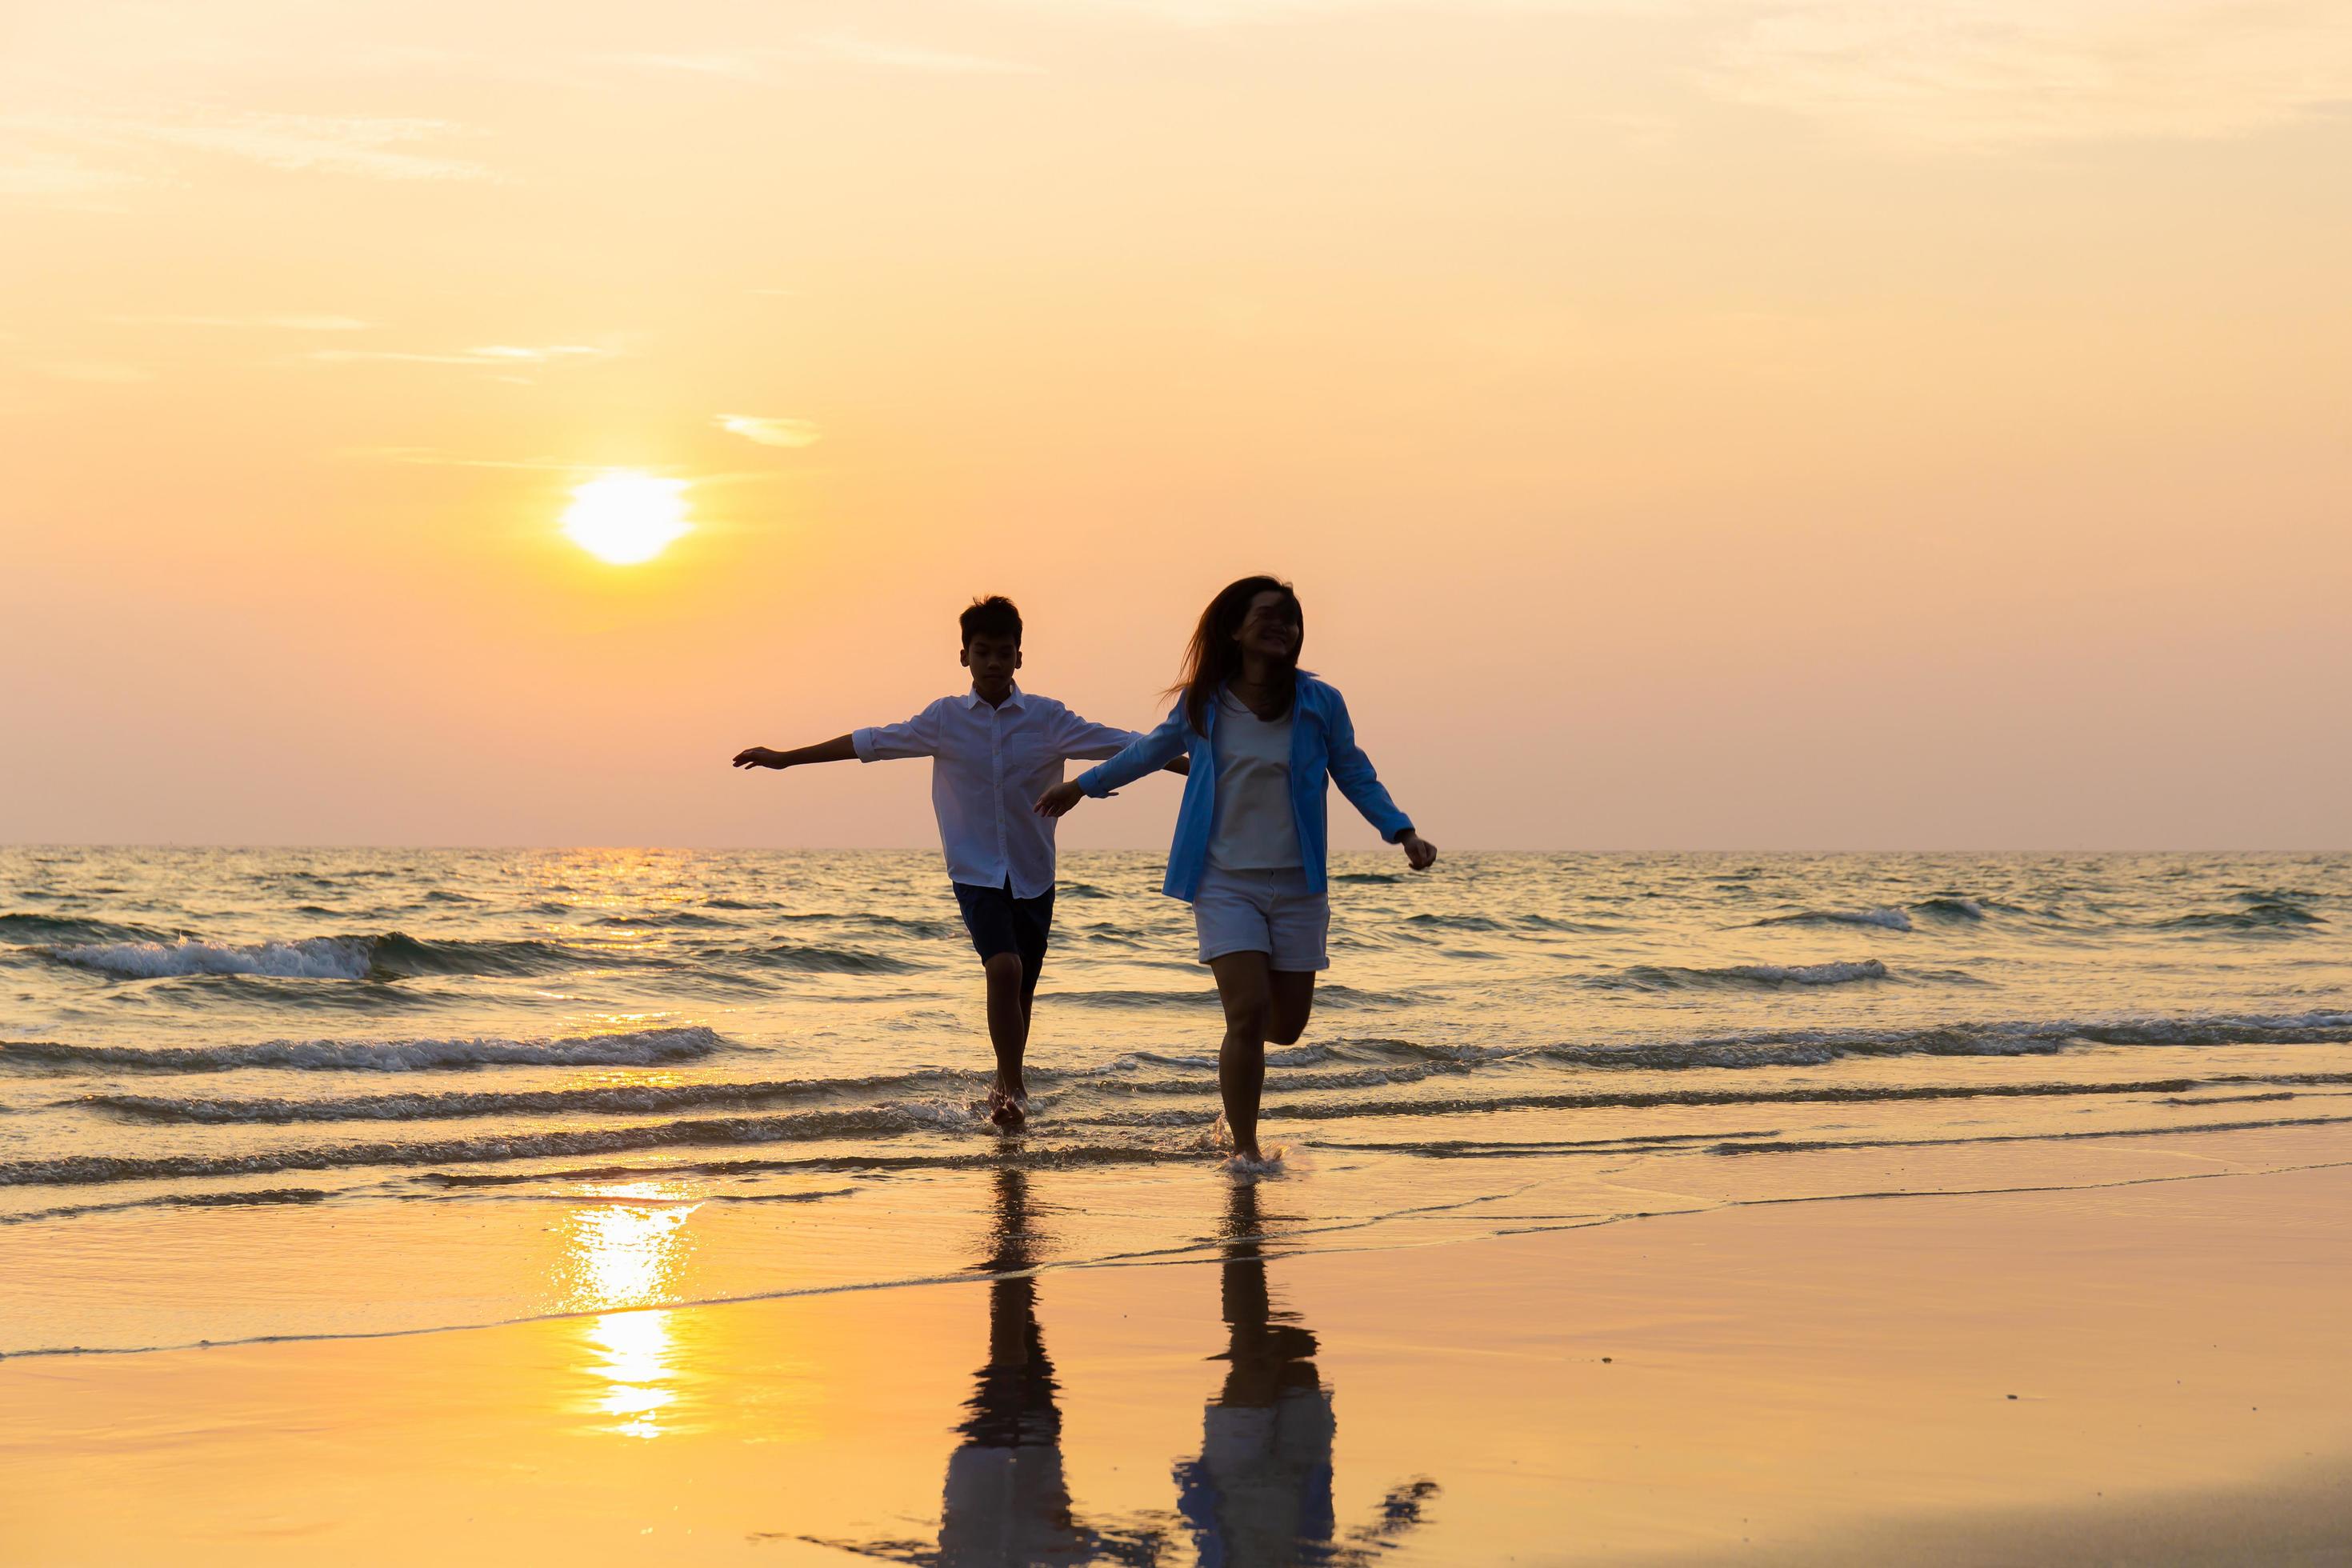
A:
934,1168,1091,1568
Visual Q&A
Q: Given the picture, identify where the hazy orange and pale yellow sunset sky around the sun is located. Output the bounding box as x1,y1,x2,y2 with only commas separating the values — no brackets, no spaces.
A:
0,0,2352,849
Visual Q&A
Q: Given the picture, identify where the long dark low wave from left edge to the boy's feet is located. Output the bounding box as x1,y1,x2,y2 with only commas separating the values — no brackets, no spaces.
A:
0,1102,988,1187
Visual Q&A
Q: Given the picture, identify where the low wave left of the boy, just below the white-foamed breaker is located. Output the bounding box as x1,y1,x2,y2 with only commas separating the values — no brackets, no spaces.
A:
0,1025,725,1072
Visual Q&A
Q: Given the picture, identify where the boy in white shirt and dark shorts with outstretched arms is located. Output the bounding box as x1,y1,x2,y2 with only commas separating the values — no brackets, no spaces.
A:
734,594,1162,1128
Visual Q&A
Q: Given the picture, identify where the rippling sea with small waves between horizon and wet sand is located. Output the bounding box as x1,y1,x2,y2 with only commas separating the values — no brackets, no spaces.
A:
0,846,2352,1357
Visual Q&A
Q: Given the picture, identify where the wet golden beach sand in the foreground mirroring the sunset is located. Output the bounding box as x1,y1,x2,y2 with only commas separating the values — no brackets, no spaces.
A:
0,1147,2352,1563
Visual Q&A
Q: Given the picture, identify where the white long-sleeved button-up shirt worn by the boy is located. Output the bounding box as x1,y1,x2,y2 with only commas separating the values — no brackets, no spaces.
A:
849,684,1136,898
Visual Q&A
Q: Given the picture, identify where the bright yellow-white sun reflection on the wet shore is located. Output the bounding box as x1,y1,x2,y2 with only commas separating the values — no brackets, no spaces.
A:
560,1182,698,1438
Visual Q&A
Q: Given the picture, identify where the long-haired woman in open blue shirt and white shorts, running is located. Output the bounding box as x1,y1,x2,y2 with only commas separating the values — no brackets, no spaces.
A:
1038,576,1437,1162
